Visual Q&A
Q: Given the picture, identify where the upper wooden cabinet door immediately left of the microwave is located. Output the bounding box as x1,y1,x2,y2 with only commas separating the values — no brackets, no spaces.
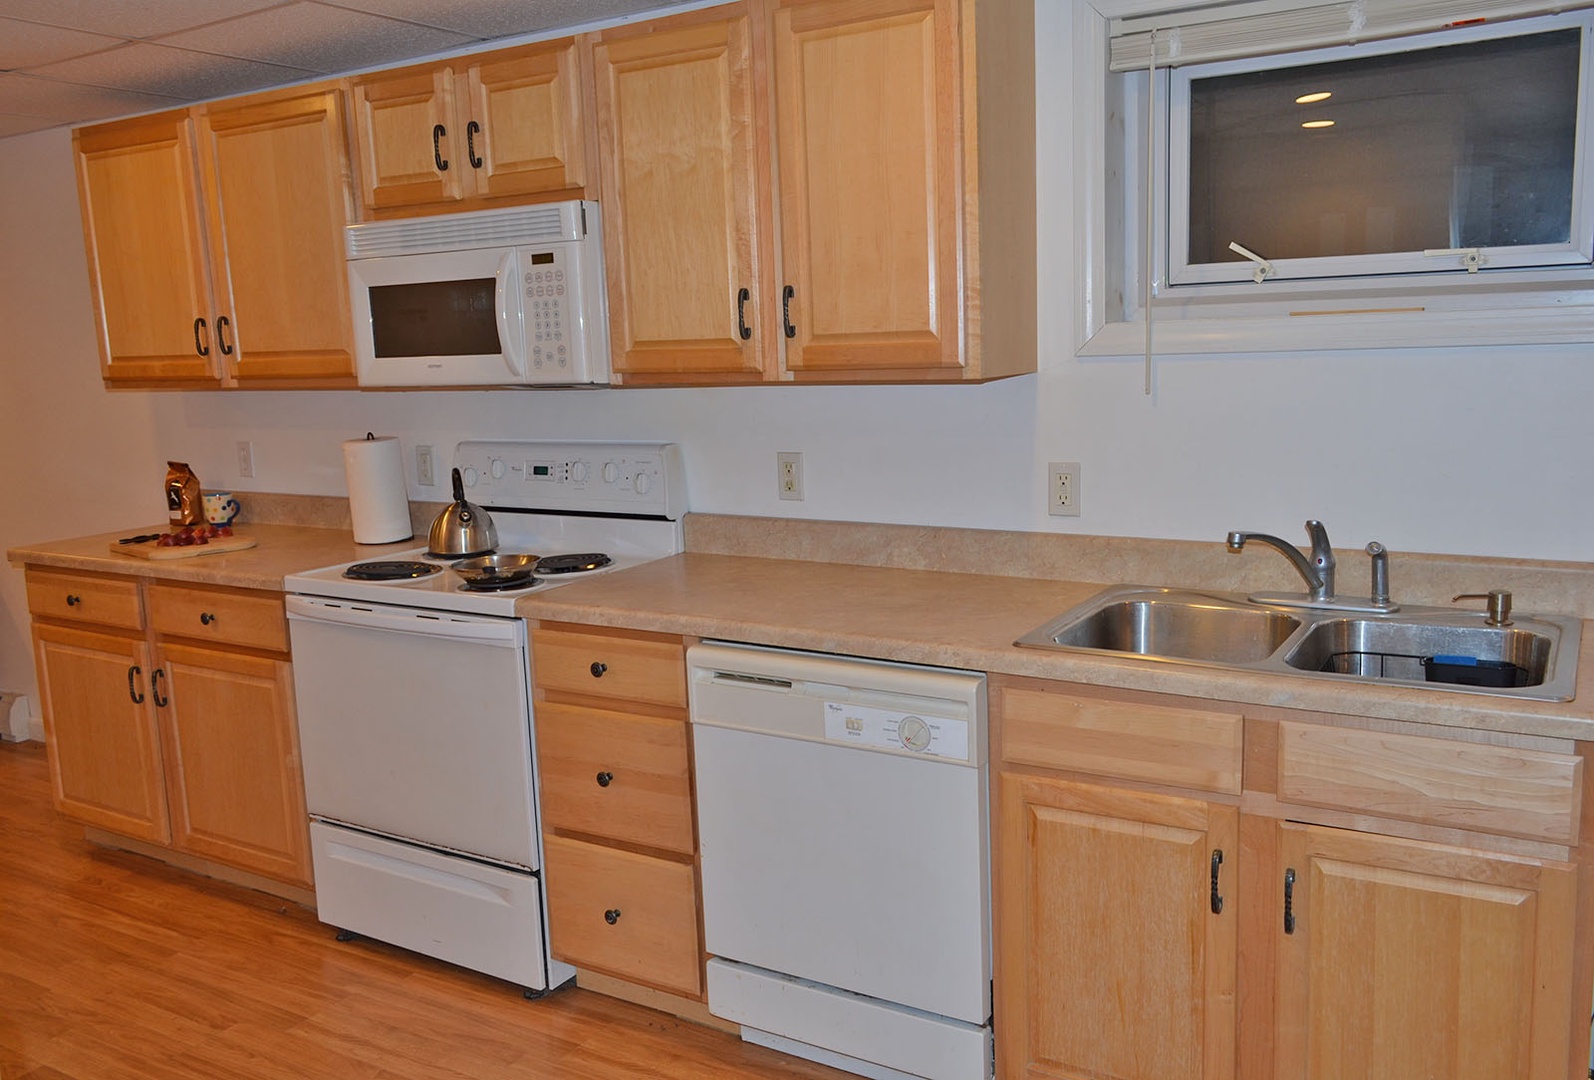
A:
199,89,354,382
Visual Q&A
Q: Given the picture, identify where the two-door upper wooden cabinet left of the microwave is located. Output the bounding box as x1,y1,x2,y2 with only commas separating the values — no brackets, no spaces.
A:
73,88,354,385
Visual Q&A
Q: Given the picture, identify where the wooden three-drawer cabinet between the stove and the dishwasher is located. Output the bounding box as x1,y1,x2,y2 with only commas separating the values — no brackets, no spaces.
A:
531,623,705,1000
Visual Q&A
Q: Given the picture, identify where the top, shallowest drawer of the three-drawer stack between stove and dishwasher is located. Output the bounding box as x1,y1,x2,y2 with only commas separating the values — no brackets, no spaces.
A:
531,626,687,709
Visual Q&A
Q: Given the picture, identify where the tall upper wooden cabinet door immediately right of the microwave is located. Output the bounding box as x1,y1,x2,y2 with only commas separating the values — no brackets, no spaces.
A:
595,5,778,382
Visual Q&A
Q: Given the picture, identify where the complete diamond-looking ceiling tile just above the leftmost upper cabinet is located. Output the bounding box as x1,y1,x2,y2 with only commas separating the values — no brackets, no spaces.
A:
28,41,316,100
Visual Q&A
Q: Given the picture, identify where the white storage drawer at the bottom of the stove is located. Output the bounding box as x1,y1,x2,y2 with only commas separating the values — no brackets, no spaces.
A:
309,820,548,989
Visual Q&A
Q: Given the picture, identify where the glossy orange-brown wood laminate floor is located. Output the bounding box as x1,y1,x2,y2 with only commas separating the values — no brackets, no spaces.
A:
0,742,848,1080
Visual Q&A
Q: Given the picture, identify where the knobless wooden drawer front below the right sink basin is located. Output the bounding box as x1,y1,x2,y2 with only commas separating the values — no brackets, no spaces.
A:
1278,722,1583,844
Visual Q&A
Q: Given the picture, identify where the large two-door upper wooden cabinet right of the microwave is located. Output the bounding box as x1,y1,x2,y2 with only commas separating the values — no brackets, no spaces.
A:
593,0,1036,384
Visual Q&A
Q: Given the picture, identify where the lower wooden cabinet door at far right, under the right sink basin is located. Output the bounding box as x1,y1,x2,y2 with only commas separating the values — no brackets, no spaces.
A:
1270,824,1586,1080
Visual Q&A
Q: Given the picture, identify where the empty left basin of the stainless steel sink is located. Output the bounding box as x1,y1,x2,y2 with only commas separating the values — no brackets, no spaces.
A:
1019,589,1301,664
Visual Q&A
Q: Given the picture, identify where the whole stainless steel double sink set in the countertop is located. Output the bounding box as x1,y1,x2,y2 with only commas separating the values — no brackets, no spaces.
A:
1015,585,1583,701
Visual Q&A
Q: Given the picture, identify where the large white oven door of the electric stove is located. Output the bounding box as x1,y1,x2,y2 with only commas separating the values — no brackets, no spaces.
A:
287,596,540,870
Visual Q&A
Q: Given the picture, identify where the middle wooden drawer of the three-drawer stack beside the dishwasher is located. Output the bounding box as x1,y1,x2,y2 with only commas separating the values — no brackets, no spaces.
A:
537,701,695,855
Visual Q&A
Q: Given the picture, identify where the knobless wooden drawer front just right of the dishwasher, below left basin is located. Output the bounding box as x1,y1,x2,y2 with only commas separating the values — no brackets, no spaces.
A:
998,688,1245,795
